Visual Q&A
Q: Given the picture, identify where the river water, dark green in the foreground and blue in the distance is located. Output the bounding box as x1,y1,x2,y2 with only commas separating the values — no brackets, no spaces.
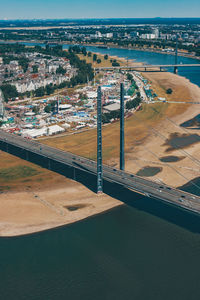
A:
0,41,200,300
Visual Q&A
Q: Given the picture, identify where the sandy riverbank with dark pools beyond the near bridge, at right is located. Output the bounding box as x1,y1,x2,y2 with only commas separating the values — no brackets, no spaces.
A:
126,73,200,187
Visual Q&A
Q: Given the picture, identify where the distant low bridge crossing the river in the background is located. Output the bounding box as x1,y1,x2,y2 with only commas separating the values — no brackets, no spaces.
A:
94,64,200,73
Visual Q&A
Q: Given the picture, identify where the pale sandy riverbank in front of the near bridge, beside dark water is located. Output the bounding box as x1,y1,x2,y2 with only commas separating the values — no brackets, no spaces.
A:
0,178,122,236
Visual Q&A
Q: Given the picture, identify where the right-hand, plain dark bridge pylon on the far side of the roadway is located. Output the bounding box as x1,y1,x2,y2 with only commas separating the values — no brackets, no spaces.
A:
120,83,124,170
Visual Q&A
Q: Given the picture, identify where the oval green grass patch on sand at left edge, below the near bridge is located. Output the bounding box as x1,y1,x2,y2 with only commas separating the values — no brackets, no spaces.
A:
0,166,40,182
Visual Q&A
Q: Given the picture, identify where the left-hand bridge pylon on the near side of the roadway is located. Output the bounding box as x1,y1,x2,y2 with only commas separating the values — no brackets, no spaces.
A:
97,86,103,194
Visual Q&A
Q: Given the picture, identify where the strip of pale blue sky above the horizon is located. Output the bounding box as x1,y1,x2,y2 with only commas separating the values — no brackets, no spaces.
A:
0,0,200,20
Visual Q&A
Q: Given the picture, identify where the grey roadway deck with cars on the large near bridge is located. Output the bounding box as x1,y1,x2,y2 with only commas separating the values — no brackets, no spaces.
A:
0,131,200,214
